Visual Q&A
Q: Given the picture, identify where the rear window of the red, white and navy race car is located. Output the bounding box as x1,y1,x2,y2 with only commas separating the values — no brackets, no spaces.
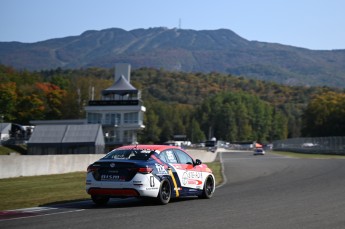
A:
104,149,154,161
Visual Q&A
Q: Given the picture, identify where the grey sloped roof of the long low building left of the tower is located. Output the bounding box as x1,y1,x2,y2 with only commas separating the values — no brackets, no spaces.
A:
28,124,104,144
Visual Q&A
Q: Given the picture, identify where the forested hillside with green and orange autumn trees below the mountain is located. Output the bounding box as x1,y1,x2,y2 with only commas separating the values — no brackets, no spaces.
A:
0,66,345,143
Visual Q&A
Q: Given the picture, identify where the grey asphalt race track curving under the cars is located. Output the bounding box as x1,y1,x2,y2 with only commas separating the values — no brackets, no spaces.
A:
0,152,345,229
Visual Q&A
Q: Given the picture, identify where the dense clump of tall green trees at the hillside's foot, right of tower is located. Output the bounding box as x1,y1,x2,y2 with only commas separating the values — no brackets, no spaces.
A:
197,92,287,142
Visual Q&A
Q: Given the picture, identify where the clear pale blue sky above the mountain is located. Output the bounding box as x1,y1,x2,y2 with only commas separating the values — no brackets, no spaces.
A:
0,0,345,50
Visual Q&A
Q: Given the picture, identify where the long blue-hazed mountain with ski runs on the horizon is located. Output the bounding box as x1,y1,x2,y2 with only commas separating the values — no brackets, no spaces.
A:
0,27,345,88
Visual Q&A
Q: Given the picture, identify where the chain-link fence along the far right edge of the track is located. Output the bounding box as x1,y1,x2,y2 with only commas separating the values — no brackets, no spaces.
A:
273,137,345,155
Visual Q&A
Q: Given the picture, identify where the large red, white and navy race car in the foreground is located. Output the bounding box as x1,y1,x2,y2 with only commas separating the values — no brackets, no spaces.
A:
86,145,215,205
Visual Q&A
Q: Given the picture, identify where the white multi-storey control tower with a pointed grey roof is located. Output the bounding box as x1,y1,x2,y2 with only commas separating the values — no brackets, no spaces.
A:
84,64,146,148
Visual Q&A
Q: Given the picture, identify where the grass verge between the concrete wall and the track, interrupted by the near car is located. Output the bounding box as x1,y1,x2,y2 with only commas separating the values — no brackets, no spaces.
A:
0,162,222,210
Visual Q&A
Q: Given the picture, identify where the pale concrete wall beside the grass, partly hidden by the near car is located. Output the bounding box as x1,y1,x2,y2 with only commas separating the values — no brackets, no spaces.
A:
0,150,217,179
